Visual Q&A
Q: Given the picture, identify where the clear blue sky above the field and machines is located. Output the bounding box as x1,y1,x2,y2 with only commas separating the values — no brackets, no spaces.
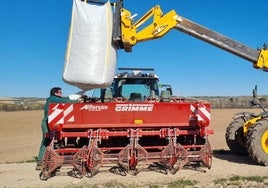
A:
0,0,268,97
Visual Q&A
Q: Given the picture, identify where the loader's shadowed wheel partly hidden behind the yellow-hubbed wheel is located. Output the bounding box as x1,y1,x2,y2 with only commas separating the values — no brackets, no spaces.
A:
225,117,248,155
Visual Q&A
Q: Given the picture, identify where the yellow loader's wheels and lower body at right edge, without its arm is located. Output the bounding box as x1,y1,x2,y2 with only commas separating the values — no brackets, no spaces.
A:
225,86,268,166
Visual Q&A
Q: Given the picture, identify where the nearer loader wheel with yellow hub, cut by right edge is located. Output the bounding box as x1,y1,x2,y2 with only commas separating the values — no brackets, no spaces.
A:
246,120,268,166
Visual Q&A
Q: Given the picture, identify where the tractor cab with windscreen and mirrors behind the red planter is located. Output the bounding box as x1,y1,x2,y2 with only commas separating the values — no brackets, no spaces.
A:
93,68,172,102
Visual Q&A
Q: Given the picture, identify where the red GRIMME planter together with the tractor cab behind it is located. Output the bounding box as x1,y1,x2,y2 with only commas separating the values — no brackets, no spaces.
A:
40,68,213,180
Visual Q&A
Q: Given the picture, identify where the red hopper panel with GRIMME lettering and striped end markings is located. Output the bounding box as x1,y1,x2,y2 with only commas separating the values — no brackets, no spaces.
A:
48,102,210,130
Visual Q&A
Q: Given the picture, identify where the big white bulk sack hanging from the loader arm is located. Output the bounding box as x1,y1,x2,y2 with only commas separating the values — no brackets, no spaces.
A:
63,0,116,90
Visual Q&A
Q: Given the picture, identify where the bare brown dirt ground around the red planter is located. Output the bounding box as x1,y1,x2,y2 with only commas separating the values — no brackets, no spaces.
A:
0,109,268,188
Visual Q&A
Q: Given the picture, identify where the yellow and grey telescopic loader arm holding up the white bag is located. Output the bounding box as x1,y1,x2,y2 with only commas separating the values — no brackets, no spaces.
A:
113,1,268,71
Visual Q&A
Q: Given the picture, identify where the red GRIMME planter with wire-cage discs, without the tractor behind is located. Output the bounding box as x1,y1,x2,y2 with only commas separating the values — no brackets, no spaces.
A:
40,101,213,179
